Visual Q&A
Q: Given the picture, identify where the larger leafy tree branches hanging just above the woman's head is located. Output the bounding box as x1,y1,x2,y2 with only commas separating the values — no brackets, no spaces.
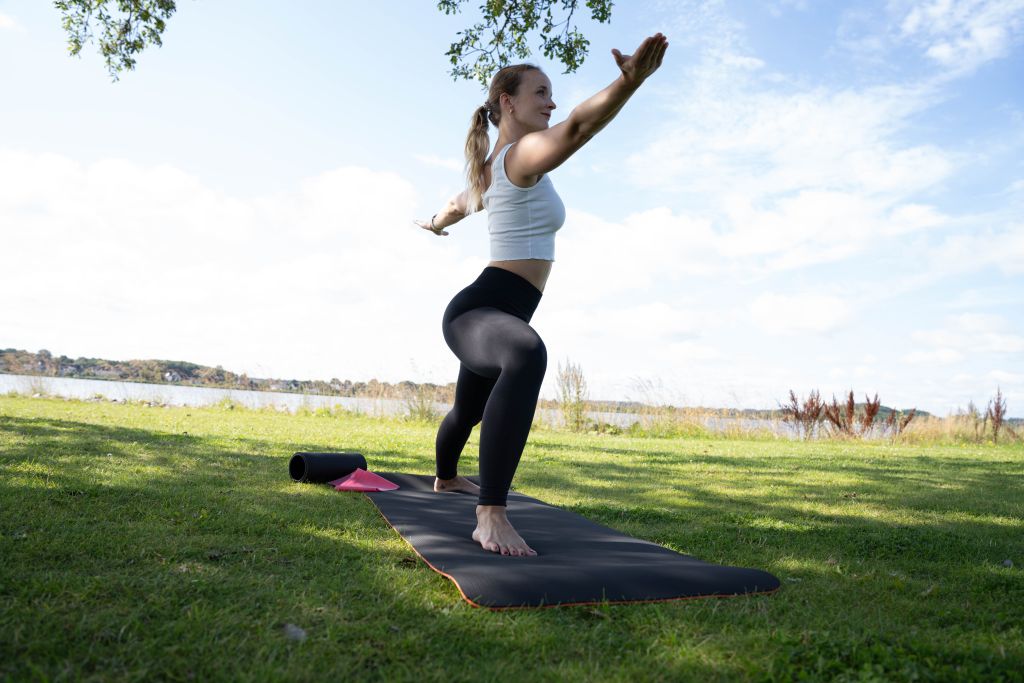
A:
437,0,612,87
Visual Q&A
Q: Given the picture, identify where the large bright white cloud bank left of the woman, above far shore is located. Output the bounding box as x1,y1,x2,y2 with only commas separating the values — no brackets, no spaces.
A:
0,148,474,381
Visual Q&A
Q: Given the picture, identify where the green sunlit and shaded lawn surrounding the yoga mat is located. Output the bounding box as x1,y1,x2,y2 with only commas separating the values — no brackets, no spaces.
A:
0,396,1024,681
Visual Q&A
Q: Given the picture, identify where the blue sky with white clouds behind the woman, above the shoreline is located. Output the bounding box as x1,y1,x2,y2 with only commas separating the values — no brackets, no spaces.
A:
0,0,1024,416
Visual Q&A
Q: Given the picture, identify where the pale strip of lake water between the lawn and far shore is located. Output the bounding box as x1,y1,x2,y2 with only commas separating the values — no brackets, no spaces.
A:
0,374,796,438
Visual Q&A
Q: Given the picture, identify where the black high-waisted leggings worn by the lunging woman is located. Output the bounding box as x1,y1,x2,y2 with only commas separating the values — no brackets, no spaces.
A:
436,266,548,505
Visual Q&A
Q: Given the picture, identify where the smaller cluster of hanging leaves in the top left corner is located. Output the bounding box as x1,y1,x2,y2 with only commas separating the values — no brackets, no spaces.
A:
53,0,176,81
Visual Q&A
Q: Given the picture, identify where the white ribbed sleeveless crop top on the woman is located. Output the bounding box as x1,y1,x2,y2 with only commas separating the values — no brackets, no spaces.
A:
483,142,565,261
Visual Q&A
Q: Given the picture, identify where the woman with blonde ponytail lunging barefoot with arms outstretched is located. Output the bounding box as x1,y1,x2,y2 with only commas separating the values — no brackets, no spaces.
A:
415,33,669,556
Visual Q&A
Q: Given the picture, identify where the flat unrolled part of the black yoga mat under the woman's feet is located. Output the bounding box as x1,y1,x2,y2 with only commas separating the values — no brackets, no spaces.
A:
366,472,779,609
